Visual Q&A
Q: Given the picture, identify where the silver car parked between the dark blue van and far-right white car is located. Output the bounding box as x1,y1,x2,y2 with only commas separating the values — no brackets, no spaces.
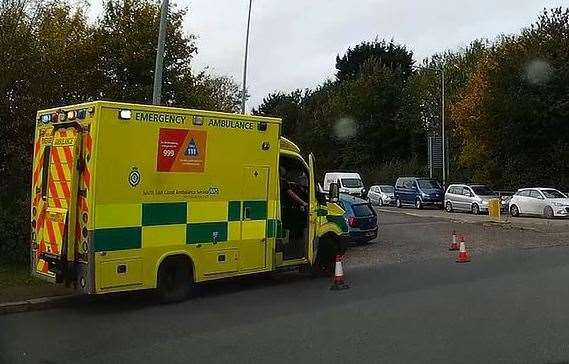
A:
445,184,498,215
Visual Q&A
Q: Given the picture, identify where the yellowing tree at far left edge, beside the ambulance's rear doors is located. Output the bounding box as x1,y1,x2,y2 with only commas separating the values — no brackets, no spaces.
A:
0,0,96,259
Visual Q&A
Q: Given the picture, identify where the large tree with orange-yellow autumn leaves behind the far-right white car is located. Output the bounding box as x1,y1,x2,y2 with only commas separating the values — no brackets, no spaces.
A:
452,8,569,188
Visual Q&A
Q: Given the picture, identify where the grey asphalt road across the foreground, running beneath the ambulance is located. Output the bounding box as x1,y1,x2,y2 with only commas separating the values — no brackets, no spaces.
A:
0,214,569,363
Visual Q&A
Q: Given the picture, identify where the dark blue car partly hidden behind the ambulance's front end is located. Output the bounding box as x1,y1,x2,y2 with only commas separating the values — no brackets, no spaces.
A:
339,193,378,243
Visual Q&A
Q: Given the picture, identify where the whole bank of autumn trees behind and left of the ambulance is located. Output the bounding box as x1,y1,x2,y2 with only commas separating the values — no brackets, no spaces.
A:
0,0,240,261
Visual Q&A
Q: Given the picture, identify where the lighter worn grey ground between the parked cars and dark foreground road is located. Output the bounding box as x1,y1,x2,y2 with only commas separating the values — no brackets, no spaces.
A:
346,209,569,267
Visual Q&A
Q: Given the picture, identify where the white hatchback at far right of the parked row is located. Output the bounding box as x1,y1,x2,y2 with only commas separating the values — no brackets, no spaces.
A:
510,188,569,219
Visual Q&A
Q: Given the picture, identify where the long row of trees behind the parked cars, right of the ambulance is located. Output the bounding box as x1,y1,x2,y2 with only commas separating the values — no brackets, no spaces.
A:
253,8,569,190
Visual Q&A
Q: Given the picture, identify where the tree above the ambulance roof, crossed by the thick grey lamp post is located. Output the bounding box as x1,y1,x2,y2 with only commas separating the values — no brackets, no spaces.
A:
95,0,196,104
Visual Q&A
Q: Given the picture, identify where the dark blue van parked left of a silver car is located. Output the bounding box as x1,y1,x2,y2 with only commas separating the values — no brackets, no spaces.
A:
395,177,445,209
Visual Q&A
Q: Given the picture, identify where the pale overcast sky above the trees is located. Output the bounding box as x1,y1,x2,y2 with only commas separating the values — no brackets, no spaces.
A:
92,0,569,109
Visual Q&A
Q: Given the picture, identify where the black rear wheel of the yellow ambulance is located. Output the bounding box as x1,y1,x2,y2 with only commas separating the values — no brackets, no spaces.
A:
158,256,193,303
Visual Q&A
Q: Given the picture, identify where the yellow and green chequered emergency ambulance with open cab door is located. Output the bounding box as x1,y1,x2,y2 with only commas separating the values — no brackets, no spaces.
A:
31,101,347,301
